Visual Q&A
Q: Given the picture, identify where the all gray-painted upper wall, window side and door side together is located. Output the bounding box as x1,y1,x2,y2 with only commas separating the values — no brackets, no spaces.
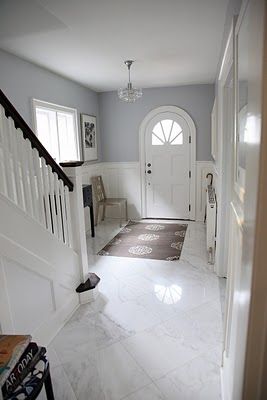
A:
0,50,214,161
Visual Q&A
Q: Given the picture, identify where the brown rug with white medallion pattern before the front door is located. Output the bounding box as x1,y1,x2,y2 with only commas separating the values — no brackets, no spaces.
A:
98,221,187,261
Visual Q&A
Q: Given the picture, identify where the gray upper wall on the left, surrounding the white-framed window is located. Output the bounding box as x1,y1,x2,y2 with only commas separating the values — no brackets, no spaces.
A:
0,50,102,160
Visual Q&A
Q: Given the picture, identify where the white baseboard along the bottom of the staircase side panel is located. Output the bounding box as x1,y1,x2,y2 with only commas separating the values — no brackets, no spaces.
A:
32,292,80,346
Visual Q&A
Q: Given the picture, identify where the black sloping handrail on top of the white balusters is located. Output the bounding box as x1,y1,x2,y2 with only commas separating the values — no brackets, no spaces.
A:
0,89,73,192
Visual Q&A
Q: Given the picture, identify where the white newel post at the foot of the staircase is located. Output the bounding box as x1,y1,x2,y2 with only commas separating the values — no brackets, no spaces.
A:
63,167,89,283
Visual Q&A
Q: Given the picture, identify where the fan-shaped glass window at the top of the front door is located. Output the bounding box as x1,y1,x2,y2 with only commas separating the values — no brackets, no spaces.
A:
152,119,183,146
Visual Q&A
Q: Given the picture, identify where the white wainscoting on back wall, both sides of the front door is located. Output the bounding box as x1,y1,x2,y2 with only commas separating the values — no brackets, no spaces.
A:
82,161,214,225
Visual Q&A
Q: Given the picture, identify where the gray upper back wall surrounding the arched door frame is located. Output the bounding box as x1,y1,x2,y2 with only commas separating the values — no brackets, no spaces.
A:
99,85,214,161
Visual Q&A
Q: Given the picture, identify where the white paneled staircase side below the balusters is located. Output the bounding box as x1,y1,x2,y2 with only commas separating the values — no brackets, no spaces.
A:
0,195,80,345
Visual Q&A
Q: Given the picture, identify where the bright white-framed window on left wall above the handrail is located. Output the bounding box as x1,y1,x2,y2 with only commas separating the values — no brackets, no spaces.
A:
33,100,80,163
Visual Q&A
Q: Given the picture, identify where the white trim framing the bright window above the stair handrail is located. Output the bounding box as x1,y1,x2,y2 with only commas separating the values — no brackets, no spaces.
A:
32,98,81,160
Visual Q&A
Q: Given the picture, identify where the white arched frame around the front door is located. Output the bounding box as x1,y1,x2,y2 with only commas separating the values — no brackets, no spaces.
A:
139,106,196,220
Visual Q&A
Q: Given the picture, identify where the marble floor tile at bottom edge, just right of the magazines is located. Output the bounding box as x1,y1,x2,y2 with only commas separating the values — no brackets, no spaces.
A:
63,343,151,400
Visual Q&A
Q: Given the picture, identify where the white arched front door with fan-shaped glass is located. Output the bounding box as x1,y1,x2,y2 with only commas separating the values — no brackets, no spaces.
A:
145,112,190,219
